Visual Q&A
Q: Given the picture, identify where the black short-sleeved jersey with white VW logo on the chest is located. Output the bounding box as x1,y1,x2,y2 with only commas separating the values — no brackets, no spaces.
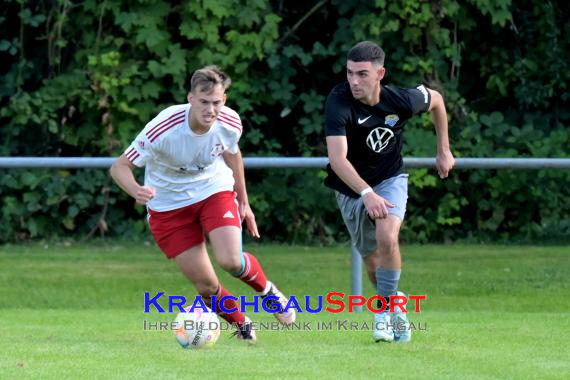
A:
325,82,431,197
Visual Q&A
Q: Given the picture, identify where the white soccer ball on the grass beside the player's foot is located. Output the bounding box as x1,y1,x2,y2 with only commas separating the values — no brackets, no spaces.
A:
174,306,220,350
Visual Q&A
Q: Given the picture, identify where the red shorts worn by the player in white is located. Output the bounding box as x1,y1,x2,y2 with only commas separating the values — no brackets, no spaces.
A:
148,191,241,259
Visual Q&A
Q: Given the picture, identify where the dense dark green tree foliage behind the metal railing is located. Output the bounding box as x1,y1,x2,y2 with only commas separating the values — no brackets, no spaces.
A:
0,0,570,243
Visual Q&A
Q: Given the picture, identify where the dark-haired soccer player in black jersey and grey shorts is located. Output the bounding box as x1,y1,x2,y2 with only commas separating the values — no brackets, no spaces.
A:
325,41,455,342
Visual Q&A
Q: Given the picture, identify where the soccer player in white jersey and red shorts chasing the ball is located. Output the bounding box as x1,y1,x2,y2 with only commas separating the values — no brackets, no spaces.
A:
111,66,295,343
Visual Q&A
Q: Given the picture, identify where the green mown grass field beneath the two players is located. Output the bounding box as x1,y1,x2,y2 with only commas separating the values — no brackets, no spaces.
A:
0,243,570,379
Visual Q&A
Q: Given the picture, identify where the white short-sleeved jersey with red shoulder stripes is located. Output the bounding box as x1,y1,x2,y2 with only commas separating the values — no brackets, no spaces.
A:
124,104,242,211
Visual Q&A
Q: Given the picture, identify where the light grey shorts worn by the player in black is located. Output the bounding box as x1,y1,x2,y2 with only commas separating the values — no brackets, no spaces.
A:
335,174,409,257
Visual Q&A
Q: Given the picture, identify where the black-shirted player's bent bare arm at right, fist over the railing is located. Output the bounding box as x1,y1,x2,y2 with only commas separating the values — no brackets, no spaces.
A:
428,89,455,178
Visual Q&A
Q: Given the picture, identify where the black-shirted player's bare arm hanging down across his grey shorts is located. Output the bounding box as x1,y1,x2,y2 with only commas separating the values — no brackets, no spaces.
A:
327,136,394,219
